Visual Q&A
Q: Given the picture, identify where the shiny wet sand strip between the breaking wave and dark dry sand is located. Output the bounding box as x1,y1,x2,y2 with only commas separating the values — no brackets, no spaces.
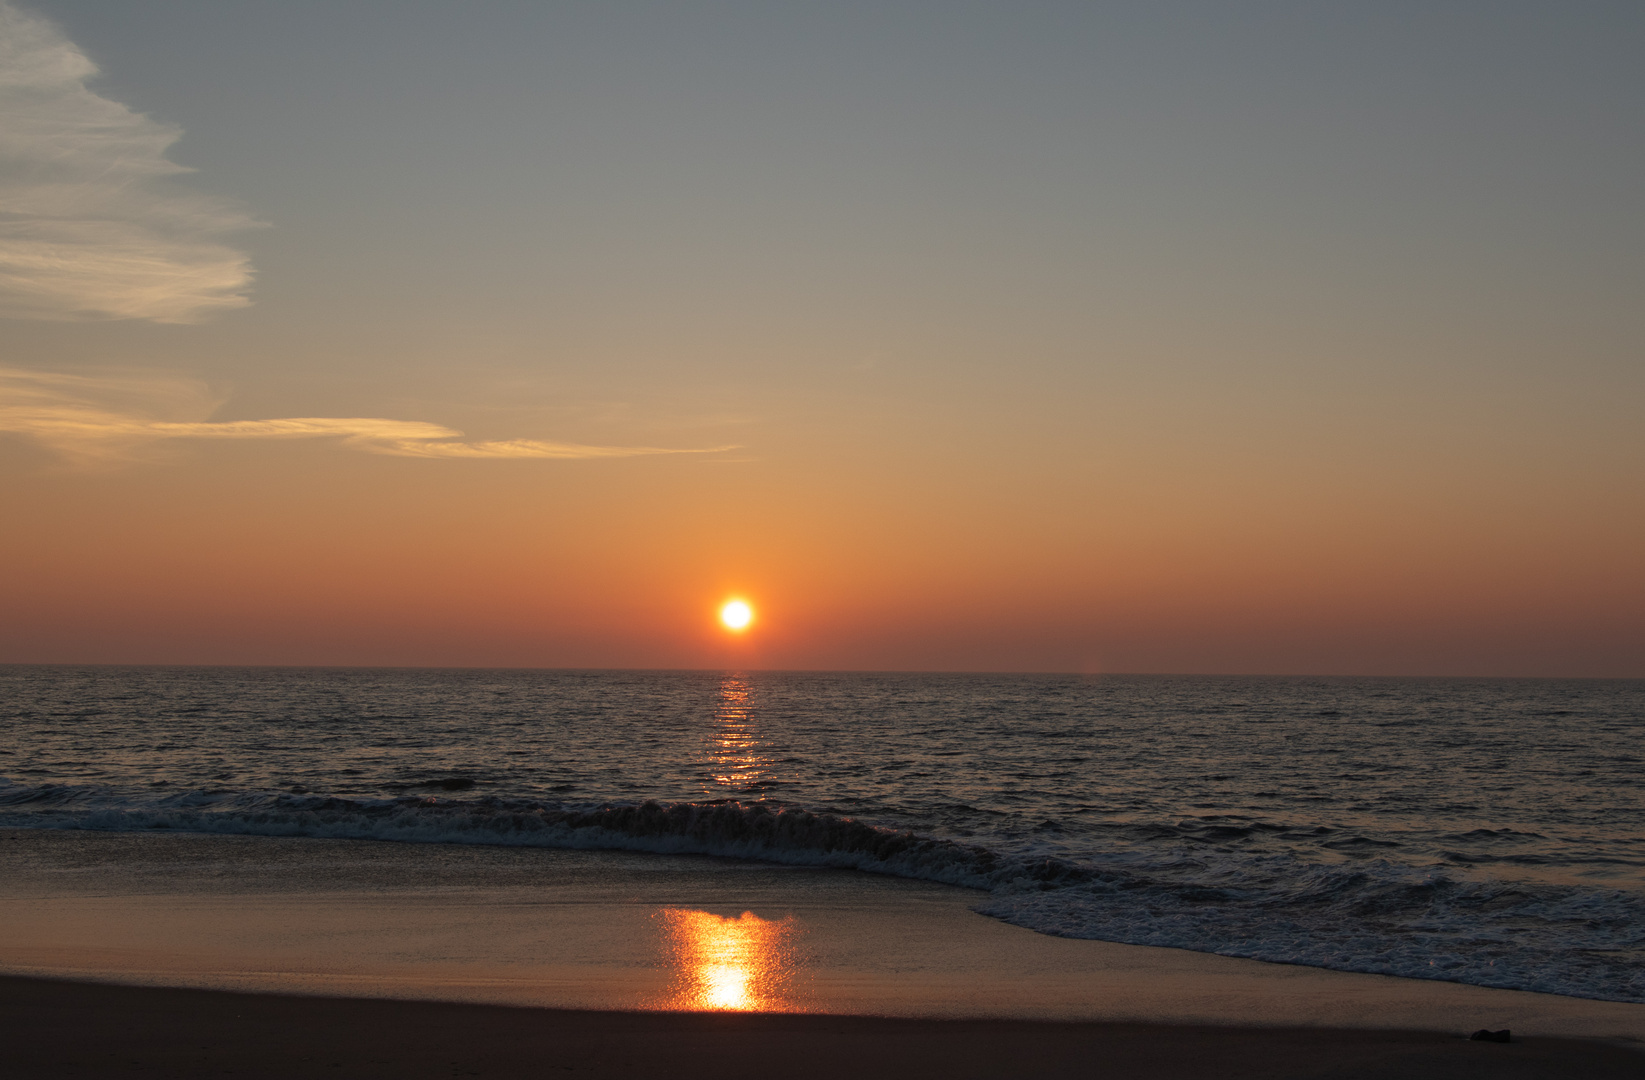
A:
0,830,1645,1047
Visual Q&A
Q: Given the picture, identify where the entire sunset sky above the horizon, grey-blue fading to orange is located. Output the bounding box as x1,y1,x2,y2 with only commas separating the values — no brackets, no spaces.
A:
0,0,1645,676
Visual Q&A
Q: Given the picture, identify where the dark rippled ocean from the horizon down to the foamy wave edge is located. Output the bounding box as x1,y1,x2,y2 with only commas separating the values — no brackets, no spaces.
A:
0,667,1645,1003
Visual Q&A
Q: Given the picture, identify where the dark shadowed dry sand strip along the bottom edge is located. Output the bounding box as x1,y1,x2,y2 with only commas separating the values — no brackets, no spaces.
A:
0,976,1645,1080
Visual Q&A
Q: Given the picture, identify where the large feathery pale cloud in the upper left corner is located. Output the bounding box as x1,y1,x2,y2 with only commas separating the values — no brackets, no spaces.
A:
0,0,255,322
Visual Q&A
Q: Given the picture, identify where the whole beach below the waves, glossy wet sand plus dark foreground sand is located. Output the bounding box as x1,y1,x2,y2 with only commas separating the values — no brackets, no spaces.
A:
0,830,1645,1077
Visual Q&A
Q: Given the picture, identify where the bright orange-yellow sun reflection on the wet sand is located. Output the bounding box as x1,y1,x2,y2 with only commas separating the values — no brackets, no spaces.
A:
656,907,801,1013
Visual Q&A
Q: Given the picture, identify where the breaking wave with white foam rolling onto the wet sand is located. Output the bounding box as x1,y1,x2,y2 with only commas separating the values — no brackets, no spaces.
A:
0,779,1645,1003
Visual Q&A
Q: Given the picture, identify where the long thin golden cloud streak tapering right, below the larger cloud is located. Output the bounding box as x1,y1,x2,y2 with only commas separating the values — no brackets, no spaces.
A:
0,368,737,462
